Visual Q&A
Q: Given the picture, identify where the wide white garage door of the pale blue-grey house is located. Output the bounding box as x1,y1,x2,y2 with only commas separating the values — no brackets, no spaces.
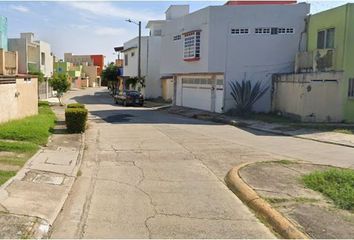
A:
181,78,223,112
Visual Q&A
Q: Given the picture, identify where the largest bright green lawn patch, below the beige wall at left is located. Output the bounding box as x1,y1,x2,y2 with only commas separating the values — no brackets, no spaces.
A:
0,102,56,145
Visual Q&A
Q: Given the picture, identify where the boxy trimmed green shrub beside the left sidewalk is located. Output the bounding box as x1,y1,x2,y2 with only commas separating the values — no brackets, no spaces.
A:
65,108,87,133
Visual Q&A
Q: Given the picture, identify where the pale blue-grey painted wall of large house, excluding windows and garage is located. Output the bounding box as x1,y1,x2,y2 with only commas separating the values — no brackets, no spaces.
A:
161,3,309,112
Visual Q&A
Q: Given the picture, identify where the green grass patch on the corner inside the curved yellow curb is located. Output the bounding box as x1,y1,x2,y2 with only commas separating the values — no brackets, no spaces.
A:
302,169,354,211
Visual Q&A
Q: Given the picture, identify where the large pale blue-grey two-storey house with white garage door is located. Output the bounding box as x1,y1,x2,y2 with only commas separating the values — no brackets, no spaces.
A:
160,1,309,112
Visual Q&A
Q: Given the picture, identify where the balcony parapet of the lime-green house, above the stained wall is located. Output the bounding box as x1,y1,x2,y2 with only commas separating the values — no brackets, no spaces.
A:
295,48,336,73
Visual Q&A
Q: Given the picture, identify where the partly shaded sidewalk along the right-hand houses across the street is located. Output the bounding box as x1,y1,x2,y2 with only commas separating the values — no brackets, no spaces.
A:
165,106,354,148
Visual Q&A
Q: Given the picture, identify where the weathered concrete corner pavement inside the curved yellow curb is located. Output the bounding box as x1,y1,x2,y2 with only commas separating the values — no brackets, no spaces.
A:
234,160,354,238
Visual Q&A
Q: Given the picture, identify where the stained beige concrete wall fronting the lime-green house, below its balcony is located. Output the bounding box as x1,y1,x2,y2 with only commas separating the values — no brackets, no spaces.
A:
272,72,344,122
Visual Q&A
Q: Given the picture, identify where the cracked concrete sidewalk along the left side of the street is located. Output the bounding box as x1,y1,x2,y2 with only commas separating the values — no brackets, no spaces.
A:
0,106,84,238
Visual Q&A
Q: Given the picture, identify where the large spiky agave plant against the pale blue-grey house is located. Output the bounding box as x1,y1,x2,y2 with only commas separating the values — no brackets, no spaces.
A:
230,80,269,114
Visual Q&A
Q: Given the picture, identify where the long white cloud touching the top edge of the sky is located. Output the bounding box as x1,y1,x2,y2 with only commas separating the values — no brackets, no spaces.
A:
63,2,163,21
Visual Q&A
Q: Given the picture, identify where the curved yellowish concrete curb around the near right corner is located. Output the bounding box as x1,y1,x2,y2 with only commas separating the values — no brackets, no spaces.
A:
225,163,309,239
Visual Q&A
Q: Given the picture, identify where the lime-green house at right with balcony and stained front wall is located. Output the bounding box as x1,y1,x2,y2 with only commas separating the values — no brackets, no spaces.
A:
273,3,354,122
